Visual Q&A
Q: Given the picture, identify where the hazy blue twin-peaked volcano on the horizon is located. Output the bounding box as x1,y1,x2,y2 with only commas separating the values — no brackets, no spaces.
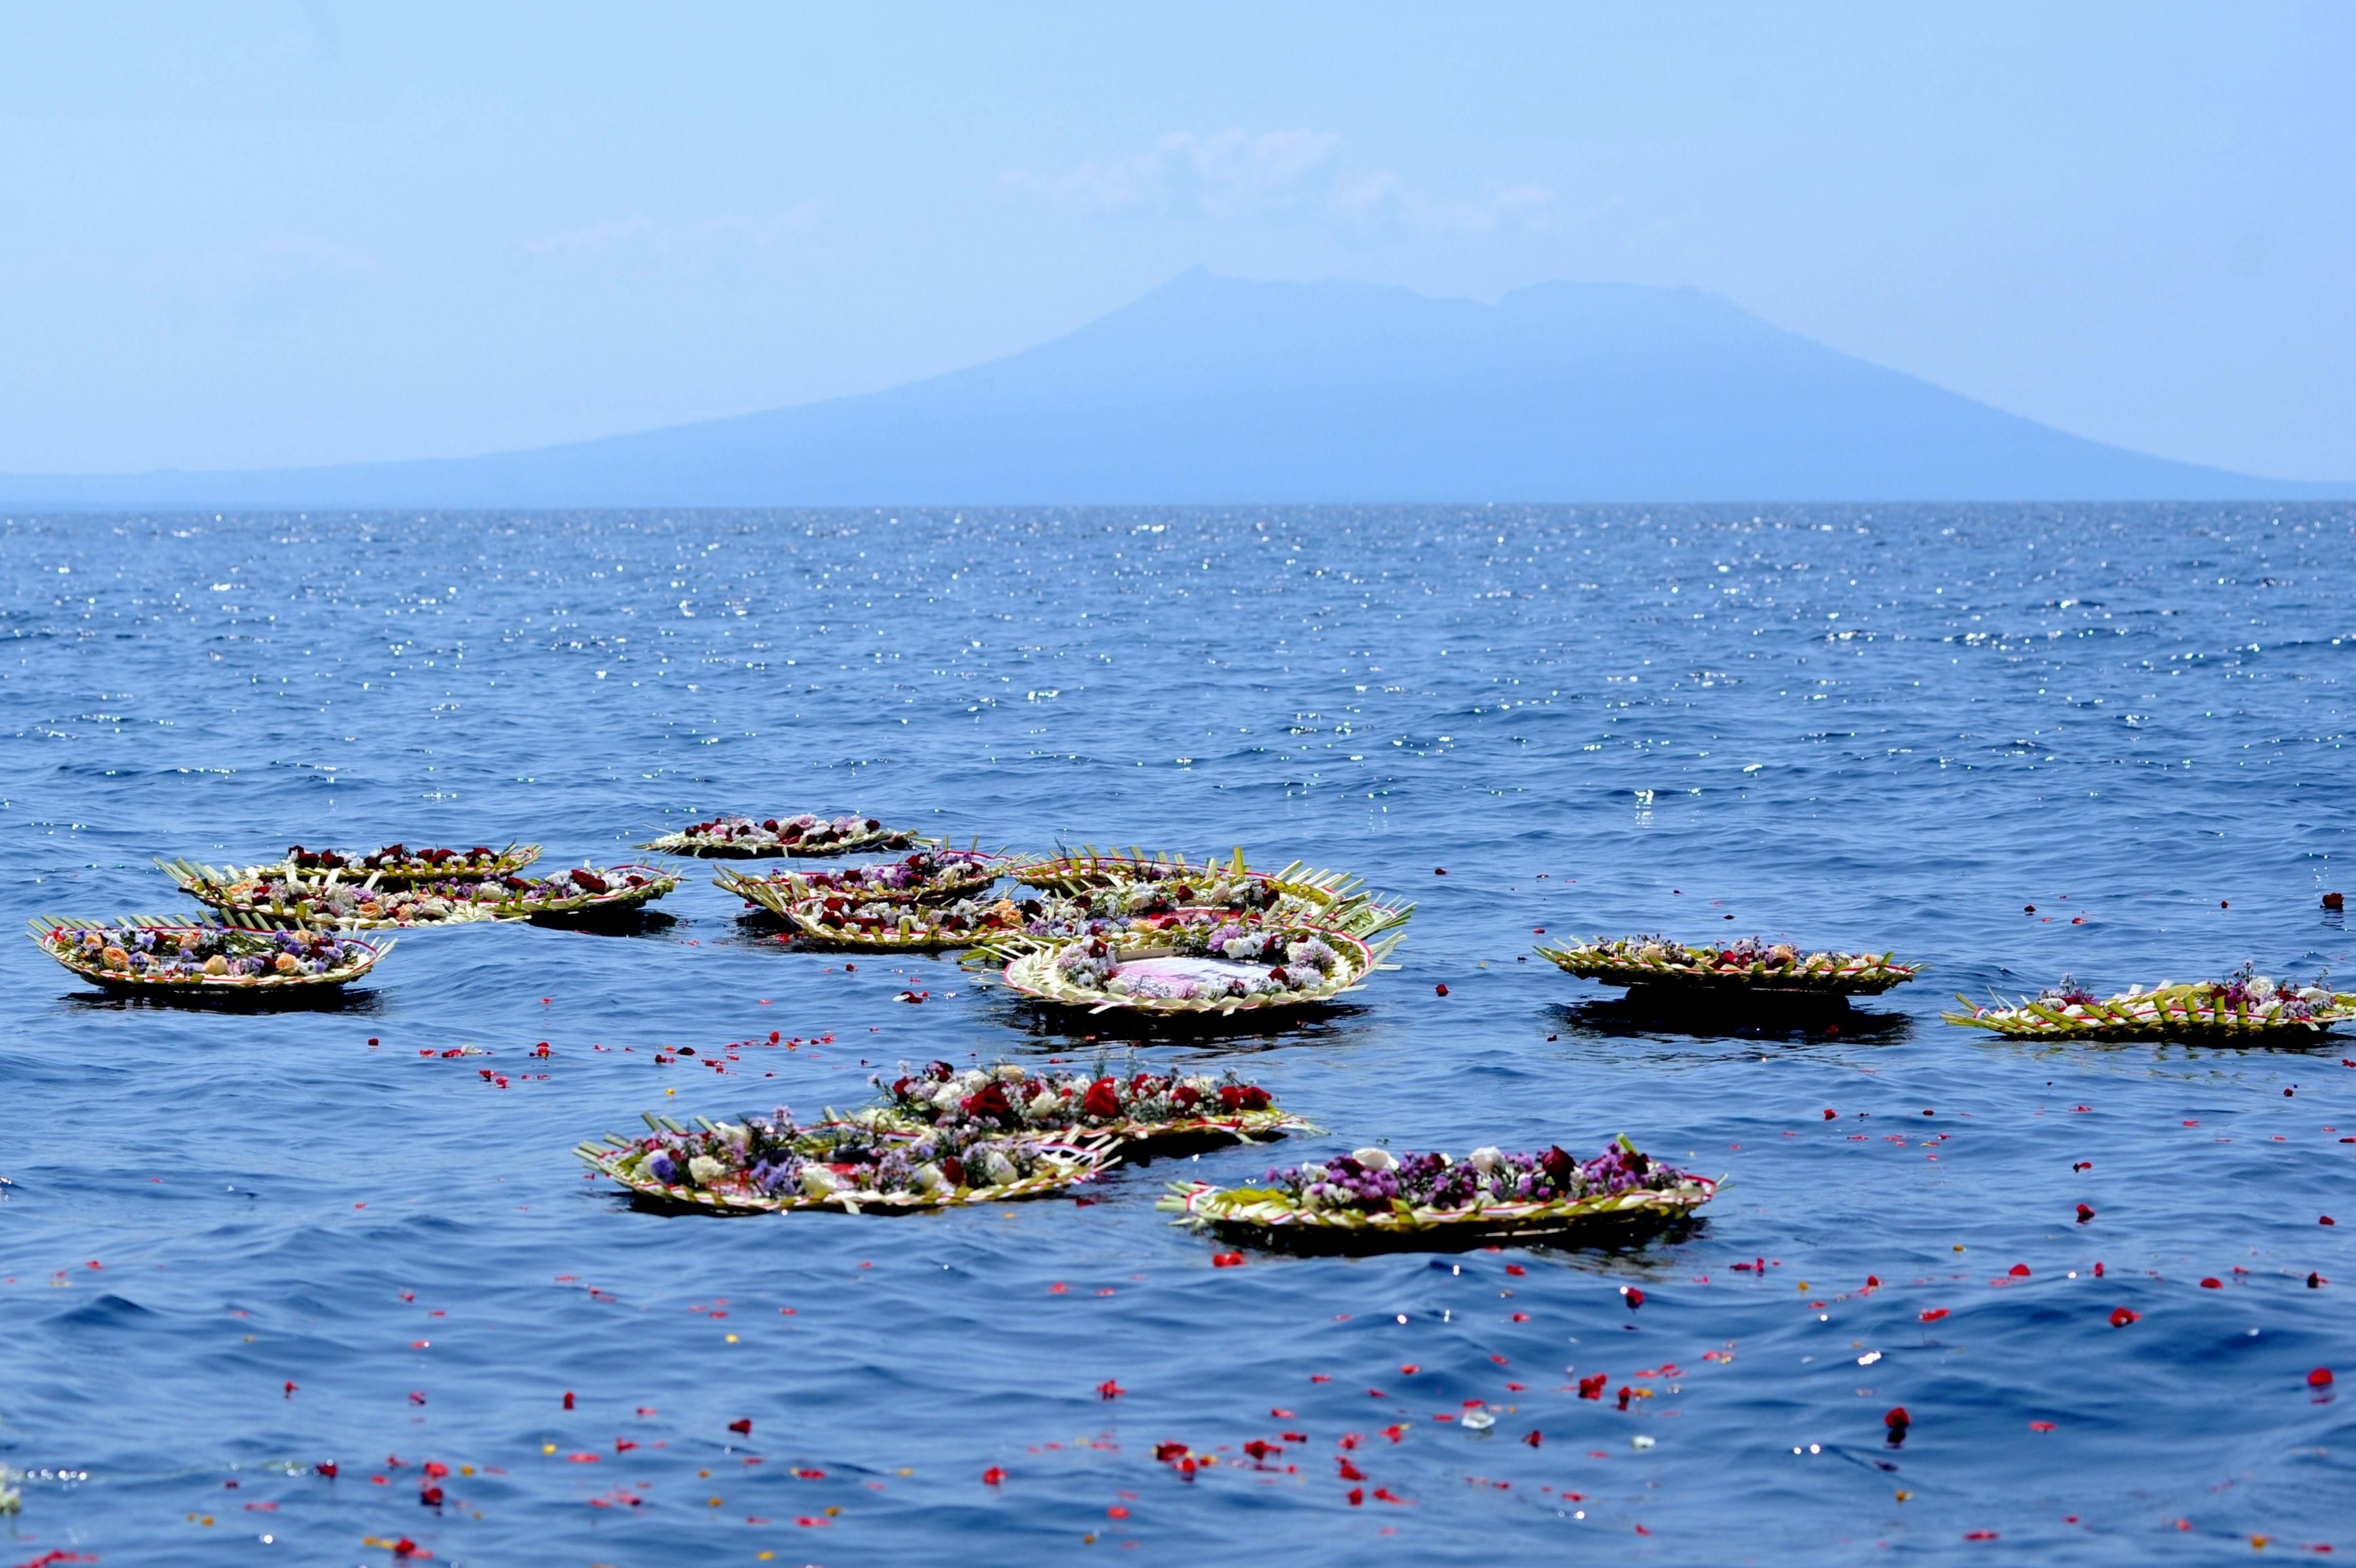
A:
0,271,2356,508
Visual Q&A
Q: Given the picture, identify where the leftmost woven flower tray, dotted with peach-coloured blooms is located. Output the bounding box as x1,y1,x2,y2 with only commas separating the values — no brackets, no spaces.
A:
31,916,394,996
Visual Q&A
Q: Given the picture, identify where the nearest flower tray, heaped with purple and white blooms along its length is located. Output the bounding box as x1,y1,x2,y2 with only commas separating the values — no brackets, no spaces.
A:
1157,1137,1718,1248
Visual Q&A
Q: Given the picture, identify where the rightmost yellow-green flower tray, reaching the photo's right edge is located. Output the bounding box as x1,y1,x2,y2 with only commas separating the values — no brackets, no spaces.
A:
1939,965,2356,1041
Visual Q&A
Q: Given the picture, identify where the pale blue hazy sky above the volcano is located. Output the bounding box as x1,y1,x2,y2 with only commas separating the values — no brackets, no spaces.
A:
0,0,2356,480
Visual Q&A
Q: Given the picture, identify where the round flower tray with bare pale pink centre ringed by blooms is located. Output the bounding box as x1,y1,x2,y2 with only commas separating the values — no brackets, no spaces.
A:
1004,918,1399,1015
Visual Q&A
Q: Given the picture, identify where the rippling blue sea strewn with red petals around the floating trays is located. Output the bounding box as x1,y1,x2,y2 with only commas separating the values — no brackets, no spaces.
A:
0,506,2356,1568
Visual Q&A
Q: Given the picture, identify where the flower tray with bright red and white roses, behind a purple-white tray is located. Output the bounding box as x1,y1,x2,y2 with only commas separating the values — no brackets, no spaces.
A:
858,1062,1315,1153
